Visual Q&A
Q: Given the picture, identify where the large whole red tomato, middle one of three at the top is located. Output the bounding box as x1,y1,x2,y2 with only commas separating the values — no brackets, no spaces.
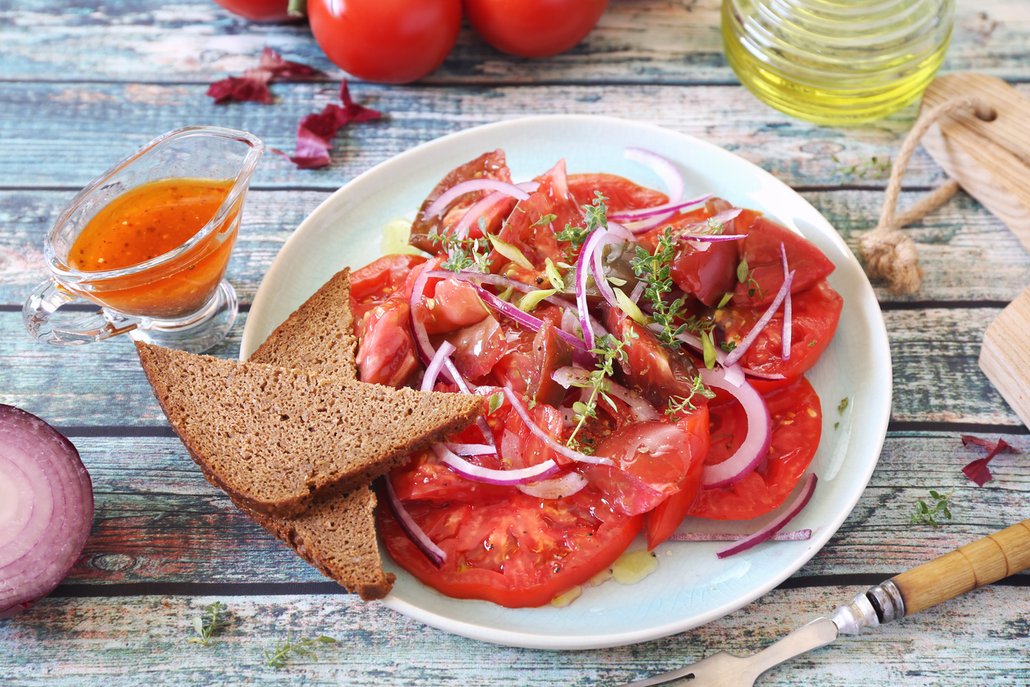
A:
308,0,461,83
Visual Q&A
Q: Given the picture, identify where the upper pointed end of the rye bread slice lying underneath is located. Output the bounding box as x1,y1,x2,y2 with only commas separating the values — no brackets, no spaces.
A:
248,268,357,380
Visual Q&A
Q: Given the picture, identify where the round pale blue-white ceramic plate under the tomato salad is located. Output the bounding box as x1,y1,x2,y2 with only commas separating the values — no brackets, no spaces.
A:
241,115,891,649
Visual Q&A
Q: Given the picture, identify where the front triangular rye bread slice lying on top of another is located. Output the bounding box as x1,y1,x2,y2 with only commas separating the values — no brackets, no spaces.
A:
136,342,482,516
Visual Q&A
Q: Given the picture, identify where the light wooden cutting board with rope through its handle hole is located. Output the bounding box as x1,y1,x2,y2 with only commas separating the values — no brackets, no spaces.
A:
923,73,1030,426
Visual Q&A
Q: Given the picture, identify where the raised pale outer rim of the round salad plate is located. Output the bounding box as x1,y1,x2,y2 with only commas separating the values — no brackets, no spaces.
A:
240,114,892,649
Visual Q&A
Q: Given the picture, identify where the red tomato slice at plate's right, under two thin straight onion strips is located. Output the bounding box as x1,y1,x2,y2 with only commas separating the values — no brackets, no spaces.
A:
716,281,844,388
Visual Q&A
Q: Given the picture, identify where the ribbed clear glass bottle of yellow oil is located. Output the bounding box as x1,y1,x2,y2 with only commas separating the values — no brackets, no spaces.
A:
722,0,955,126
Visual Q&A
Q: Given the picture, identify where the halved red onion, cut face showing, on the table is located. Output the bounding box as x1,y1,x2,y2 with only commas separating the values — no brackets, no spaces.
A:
0,404,93,618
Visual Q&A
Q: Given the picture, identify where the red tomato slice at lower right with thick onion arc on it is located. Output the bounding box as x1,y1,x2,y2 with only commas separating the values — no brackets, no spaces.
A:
689,377,823,520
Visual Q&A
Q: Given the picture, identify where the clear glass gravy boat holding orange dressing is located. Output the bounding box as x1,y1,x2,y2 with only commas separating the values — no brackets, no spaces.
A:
23,127,264,352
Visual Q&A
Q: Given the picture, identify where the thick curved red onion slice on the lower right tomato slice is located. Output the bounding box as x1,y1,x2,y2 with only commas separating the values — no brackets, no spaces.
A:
700,368,773,488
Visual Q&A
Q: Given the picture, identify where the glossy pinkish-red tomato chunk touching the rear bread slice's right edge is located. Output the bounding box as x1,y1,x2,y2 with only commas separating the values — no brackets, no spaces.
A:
355,298,418,386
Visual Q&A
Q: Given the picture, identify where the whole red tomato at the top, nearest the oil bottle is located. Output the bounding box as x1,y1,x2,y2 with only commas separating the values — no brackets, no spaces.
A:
465,0,608,58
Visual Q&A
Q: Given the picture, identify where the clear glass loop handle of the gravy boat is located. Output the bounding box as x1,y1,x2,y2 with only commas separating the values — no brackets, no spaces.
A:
22,280,139,346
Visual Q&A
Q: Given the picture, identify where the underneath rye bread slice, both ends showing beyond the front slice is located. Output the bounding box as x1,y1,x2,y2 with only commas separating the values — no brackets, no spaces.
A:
245,269,396,600
